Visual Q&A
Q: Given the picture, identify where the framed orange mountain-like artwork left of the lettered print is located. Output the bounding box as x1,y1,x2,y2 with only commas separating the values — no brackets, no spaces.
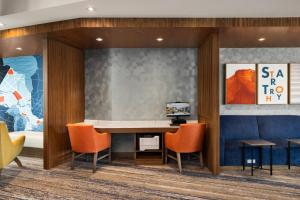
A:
226,64,256,104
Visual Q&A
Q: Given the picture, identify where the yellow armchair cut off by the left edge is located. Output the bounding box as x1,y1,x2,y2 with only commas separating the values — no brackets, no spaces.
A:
0,122,25,174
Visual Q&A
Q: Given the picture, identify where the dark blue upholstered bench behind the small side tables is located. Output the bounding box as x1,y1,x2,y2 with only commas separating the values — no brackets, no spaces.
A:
220,115,300,166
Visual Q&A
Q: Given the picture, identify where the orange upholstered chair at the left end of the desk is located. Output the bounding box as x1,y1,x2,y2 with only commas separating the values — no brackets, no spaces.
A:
67,123,111,172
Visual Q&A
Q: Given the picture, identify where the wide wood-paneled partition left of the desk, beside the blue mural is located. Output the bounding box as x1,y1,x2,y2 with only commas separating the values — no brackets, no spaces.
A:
44,39,85,169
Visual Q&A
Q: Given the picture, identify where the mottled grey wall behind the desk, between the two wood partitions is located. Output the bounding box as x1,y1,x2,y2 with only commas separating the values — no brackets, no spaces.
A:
85,48,197,152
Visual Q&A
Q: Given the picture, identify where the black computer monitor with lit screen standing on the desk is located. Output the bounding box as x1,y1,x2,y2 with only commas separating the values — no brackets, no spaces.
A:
166,102,191,126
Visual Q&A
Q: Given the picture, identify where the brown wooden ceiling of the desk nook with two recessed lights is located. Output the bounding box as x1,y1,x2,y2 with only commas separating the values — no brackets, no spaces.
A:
49,28,215,49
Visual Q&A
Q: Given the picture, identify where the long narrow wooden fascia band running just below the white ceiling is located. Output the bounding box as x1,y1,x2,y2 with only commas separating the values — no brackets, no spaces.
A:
0,17,300,39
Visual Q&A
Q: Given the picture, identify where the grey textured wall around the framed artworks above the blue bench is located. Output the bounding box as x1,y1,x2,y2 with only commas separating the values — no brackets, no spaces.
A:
220,48,300,115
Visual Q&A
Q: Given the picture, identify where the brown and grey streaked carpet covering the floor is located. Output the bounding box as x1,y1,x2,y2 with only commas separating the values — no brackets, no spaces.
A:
0,157,300,200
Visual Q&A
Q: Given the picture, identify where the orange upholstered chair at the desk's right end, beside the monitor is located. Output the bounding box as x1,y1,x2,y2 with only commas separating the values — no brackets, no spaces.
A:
165,123,206,173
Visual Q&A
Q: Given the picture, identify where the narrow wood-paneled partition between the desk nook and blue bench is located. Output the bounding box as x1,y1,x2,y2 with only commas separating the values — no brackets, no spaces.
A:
198,32,220,174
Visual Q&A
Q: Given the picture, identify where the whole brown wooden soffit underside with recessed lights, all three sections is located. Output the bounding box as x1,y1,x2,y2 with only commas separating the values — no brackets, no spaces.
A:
0,27,300,57
